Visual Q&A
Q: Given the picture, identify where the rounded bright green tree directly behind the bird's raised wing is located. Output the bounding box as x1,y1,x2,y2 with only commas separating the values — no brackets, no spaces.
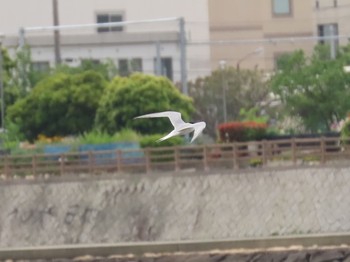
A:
96,73,194,134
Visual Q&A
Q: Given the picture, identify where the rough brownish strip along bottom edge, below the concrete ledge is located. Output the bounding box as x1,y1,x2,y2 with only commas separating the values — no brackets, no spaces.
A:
0,247,350,262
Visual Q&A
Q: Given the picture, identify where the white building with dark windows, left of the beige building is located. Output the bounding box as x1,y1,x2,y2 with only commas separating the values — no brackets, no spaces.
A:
0,0,210,89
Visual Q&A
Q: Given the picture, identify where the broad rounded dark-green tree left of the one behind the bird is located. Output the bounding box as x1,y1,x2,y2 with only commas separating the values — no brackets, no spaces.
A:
8,71,106,140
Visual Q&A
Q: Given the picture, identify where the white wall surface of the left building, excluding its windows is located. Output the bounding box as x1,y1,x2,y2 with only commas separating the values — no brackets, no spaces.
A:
0,0,210,82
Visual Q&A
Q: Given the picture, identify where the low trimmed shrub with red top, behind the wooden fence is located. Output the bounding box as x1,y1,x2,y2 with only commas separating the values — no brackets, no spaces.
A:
218,121,267,142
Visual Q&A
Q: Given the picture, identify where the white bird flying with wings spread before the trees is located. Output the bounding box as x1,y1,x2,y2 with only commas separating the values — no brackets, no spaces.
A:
135,111,206,143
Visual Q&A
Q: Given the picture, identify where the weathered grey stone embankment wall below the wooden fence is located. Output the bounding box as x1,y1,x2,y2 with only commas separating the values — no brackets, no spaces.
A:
0,167,350,247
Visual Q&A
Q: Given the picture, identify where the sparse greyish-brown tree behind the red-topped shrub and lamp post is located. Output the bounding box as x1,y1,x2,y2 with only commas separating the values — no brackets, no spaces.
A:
189,67,269,137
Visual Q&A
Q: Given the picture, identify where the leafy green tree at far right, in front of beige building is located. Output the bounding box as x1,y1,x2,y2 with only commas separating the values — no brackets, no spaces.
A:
271,45,350,132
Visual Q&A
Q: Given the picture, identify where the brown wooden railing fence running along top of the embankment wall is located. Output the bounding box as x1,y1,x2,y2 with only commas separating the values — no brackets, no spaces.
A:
0,137,350,176
